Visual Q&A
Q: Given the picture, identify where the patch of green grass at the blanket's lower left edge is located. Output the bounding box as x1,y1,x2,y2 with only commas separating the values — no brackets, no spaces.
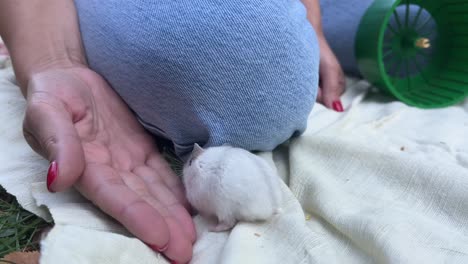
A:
0,187,50,258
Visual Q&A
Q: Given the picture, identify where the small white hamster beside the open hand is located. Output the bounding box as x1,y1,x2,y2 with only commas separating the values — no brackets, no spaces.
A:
183,144,282,232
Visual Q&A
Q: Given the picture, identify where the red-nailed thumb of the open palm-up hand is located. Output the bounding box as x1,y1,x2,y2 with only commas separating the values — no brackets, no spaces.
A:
23,92,85,192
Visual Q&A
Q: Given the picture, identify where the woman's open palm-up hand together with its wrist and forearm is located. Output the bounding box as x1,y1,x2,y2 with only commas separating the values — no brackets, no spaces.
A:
0,0,195,263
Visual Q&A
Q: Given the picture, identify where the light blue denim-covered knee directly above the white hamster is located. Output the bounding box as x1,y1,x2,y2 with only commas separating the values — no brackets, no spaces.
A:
75,0,319,157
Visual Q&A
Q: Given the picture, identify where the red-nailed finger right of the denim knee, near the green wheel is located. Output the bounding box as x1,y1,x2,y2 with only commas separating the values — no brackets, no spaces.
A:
320,67,345,110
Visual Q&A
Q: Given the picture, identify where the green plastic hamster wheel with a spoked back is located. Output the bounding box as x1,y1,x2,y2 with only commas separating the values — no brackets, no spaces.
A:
355,0,468,108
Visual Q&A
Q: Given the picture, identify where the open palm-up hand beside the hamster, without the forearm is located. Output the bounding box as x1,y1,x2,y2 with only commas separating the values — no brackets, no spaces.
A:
24,66,196,263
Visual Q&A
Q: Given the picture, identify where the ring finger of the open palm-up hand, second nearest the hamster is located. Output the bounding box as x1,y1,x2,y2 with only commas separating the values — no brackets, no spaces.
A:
134,166,196,243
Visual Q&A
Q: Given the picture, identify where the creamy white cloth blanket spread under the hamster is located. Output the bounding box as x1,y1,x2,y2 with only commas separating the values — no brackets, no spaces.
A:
0,52,468,264
